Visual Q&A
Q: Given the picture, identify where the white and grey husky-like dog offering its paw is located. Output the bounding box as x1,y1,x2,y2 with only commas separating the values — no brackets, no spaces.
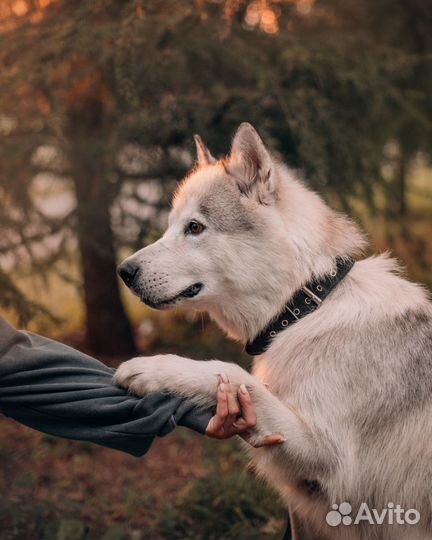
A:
116,124,432,540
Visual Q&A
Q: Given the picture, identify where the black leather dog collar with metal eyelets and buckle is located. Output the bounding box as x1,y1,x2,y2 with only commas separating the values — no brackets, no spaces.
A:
245,258,354,356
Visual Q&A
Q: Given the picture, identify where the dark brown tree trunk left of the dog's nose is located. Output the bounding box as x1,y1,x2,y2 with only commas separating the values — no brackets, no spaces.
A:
71,141,136,355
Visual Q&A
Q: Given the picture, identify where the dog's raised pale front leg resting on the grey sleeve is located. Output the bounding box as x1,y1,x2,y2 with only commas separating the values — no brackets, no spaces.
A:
114,354,328,475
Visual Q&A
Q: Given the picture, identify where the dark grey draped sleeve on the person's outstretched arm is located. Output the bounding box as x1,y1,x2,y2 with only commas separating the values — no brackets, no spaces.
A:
0,318,212,456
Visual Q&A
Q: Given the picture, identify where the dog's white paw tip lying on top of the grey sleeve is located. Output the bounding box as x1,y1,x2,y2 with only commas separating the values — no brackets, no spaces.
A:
114,355,180,396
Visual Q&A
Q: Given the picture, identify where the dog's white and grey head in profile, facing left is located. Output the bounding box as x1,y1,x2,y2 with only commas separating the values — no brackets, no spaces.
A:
119,124,364,340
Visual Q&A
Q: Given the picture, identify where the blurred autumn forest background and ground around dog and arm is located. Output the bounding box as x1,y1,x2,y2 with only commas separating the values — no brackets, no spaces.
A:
0,0,432,540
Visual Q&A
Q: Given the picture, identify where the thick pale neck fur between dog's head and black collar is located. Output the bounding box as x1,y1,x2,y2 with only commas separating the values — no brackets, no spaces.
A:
208,185,366,343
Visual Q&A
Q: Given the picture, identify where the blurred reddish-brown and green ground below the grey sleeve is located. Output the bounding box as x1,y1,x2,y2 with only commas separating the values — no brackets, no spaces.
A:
0,412,284,540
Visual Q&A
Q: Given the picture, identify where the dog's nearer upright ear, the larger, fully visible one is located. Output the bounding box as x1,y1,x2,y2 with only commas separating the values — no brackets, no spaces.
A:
227,122,276,204
